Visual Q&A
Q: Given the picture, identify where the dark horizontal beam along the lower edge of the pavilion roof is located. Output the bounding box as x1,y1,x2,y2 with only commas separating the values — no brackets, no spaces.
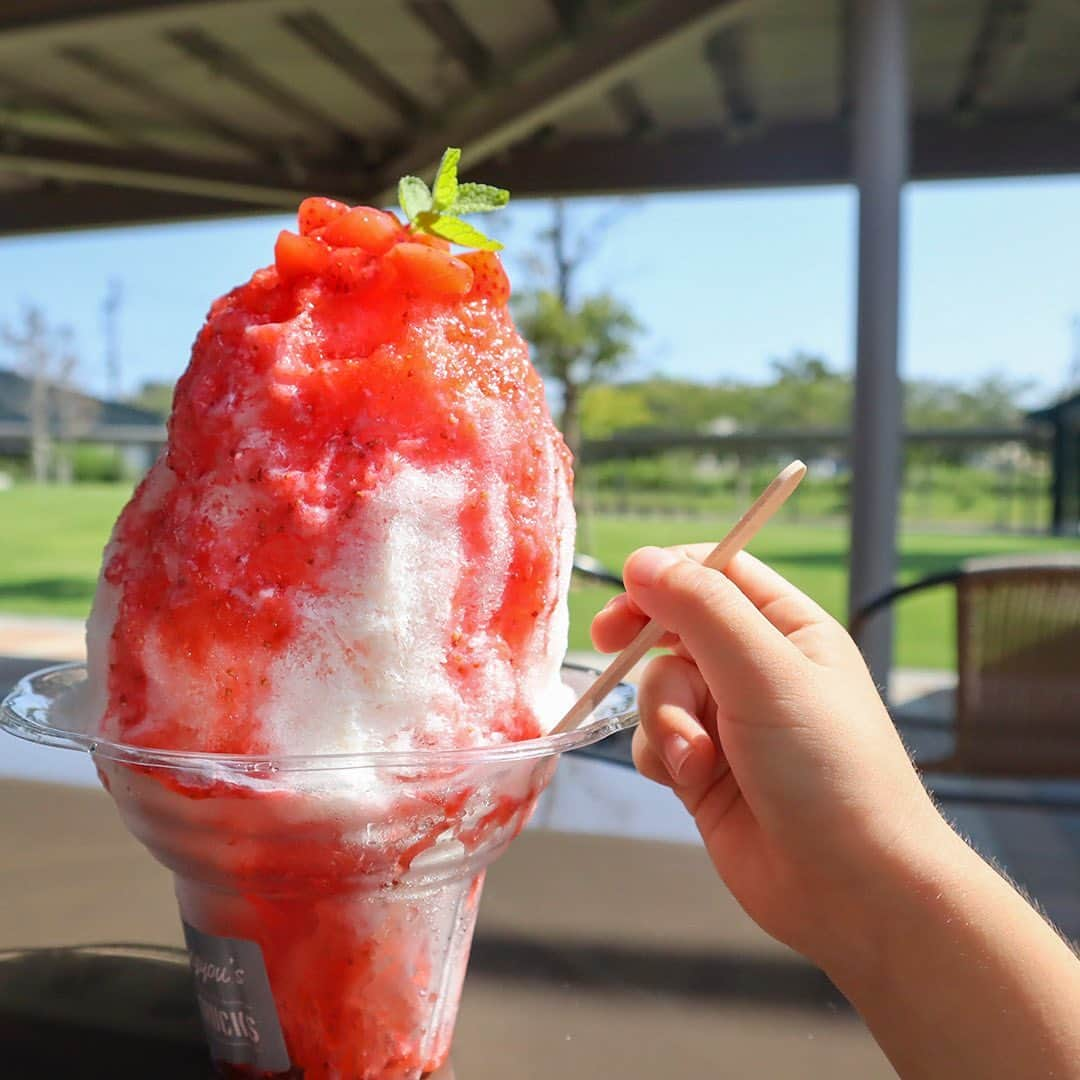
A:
0,108,1080,233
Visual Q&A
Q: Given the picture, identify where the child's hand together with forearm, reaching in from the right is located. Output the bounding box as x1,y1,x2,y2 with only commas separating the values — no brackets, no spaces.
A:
593,545,1080,1080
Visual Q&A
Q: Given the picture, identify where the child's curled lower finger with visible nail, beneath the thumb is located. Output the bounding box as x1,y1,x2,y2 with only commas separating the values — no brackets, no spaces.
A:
634,656,717,788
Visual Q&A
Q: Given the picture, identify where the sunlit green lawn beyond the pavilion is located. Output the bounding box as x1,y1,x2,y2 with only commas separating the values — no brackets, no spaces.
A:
0,485,1077,667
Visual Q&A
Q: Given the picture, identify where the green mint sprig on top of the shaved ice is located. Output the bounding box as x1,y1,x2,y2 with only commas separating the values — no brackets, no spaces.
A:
397,146,510,252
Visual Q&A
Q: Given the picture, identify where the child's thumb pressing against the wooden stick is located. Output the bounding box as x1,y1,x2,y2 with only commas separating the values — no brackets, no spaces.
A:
623,548,801,697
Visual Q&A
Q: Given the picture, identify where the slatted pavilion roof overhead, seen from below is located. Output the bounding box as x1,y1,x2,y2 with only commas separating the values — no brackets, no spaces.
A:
0,0,1080,232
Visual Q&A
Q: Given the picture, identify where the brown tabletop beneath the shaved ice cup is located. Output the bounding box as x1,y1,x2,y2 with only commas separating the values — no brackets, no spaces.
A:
0,761,894,1080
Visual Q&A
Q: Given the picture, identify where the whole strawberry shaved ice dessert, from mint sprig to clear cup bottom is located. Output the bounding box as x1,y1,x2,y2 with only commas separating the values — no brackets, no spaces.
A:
86,151,573,1080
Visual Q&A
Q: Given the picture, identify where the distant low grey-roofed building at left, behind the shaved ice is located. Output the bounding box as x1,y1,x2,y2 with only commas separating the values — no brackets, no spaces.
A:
0,368,165,473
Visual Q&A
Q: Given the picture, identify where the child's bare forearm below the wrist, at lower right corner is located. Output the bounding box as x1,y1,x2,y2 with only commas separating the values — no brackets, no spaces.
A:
827,828,1080,1080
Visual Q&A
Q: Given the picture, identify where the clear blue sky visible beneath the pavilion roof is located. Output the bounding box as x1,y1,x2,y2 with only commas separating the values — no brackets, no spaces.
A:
0,177,1080,401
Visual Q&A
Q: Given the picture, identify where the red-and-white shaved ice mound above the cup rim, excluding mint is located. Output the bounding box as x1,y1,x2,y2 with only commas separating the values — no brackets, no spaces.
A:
87,164,573,754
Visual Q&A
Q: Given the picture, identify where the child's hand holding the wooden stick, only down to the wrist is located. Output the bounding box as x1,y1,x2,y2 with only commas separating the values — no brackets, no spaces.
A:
593,544,955,968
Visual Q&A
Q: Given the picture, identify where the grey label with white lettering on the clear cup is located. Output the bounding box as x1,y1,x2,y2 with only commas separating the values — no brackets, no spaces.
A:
184,922,291,1072
